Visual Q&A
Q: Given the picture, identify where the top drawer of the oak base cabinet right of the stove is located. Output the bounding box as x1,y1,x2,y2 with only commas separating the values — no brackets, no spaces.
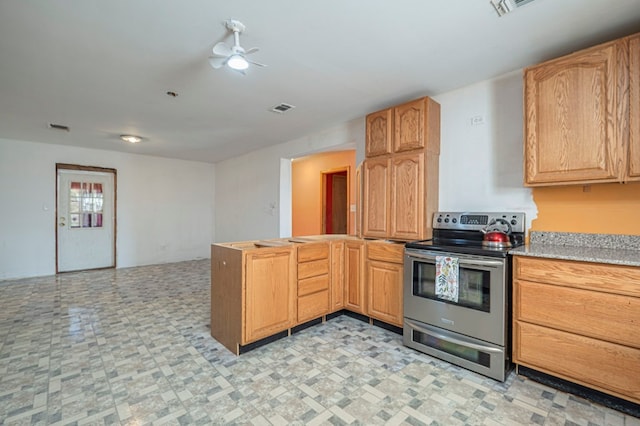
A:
514,256,640,297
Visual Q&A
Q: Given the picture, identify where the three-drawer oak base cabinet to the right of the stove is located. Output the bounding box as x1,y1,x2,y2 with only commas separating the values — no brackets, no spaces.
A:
513,256,640,404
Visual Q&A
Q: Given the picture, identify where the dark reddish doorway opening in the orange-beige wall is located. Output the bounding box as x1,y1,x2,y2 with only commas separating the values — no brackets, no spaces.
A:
322,167,349,234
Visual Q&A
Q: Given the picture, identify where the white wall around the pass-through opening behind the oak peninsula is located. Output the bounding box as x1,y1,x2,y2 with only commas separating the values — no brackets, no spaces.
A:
215,119,364,242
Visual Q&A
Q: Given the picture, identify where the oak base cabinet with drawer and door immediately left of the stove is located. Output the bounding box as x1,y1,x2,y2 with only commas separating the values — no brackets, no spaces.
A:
367,242,404,327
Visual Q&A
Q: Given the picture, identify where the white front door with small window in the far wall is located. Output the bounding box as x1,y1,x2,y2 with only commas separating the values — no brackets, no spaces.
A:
56,164,115,272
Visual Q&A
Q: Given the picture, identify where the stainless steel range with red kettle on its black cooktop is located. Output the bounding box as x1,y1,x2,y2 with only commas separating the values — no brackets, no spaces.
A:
403,212,525,381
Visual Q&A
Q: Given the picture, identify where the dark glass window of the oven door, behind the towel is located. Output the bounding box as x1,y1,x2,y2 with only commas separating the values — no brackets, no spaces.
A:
413,261,491,312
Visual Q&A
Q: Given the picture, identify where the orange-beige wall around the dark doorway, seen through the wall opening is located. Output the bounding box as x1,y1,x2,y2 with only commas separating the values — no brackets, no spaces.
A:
291,150,356,237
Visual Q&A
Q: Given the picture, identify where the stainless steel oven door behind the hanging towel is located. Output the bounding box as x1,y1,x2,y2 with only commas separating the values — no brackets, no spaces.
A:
404,249,508,346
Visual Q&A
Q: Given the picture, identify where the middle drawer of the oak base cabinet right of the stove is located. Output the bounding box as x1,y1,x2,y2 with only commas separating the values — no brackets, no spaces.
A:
513,280,640,348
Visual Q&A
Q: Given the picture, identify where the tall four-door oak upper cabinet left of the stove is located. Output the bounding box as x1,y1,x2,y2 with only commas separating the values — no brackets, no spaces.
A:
362,98,440,241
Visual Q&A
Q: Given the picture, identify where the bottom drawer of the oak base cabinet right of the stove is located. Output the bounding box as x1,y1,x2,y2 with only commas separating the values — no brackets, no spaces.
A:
513,321,640,403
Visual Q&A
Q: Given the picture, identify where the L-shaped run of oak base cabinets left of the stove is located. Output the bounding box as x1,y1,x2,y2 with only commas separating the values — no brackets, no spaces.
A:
211,235,404,355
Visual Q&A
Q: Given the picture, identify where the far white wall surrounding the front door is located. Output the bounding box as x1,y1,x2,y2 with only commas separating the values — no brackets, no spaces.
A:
0,139,215,279
